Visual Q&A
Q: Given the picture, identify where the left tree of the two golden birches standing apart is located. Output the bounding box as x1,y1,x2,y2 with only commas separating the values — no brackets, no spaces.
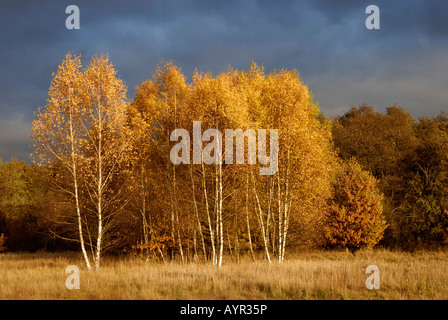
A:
32,53,91,270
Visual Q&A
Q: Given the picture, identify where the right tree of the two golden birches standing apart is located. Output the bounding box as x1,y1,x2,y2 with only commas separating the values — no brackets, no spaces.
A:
83,55,131,270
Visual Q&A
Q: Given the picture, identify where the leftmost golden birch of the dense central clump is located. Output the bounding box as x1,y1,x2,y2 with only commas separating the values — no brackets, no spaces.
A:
129,62,189,261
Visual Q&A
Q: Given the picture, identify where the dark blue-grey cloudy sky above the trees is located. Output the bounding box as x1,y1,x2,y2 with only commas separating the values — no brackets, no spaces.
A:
0,0,448,161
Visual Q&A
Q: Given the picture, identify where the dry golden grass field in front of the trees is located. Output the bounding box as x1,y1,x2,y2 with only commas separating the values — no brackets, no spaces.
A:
0,249,448,300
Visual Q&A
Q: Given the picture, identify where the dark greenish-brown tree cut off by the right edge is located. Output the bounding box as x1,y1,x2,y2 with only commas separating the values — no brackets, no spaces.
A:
397,114,448,243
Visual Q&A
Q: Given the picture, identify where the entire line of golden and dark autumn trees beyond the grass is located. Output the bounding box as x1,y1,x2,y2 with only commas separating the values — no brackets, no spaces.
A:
0,53,448,270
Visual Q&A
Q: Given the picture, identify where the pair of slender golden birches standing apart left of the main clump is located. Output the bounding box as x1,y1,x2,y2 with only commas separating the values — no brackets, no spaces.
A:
33,53,129,270
